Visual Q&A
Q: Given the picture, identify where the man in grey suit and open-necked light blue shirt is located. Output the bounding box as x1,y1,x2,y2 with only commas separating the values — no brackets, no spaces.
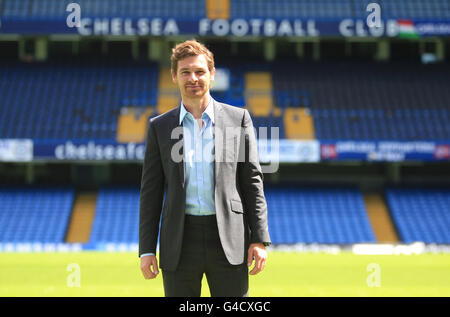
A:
139,40,270,297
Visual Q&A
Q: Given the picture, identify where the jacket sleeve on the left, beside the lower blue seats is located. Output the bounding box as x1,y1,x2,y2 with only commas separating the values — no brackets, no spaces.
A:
139,120,165,255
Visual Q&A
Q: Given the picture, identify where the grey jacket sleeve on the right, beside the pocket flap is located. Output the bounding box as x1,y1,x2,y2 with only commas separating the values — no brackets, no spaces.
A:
238,110,271,243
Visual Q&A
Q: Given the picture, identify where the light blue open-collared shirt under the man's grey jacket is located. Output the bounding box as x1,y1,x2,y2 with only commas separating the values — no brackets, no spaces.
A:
141,98,216,258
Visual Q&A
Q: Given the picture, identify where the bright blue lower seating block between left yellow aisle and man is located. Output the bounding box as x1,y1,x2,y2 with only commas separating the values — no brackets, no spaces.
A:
90,188,139,243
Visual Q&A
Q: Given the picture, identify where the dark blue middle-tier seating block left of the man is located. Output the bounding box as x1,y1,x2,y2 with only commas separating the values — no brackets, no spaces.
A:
0,61,158,140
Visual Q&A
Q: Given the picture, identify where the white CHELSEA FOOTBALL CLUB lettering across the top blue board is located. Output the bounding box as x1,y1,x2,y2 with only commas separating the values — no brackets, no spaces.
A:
70,17,398,37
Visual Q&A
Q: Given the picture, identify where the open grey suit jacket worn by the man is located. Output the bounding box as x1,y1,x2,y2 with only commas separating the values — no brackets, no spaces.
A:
139,100,270,271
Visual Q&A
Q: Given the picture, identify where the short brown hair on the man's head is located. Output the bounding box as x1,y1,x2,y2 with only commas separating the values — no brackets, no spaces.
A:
170,40,214,74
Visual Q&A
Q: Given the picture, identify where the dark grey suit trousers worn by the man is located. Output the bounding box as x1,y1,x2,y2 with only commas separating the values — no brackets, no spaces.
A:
162,215,248,297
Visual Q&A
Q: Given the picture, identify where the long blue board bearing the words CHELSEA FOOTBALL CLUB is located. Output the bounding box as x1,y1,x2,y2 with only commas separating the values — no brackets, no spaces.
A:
0,2,442,37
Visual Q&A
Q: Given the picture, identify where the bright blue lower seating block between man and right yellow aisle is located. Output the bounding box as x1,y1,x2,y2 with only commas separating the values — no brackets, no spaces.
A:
266,187,375,244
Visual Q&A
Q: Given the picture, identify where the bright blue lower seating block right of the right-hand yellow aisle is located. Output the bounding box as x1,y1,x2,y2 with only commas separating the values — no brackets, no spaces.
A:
386,188,450,244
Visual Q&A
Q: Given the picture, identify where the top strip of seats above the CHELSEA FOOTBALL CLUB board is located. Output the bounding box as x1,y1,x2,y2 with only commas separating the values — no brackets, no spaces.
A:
0,0,450,19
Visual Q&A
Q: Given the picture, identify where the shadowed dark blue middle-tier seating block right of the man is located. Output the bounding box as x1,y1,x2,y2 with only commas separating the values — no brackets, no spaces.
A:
273,61,450,140
